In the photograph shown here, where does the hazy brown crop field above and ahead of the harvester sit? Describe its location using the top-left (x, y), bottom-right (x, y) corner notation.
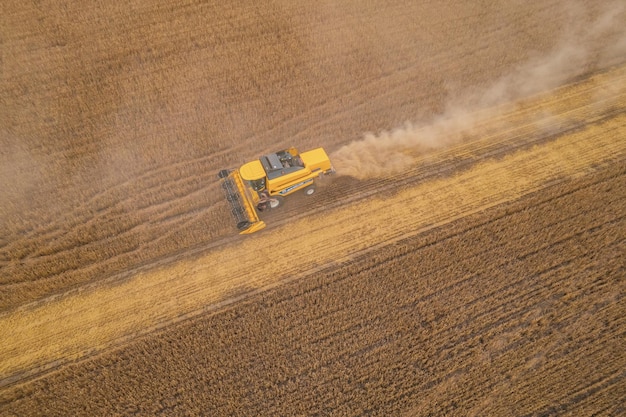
top-left (0, 0), bottom-right (620, 311)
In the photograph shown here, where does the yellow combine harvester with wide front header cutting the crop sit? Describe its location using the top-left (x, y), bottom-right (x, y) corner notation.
top-left (218, 148), bottom-right (335, 234)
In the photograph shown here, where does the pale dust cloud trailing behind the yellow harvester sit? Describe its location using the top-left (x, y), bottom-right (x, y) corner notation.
top-left (331, 1), bottom-right (626, 179)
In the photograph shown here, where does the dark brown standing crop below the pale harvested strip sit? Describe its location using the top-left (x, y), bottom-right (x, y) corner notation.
top-left (0, 158), bottom-right (626, 416)
